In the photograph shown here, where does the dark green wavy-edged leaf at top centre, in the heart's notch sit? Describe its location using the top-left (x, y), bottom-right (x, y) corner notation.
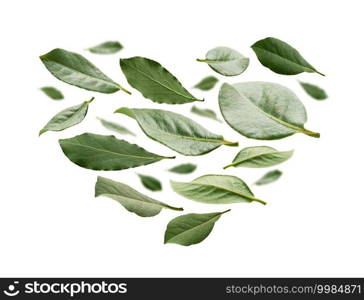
top-left (120, 56), bottom-right (203, 104)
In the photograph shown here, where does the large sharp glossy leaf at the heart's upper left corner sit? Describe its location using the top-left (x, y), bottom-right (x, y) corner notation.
top-left (40, 48), bottom-right (131, 94)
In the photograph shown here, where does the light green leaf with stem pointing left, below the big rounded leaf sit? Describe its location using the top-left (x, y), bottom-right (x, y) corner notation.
top-left (224, 146), bottom-right (293, 169)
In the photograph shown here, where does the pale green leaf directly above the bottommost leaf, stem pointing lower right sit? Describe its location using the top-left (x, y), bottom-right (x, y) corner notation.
top-left (171, 175), bottom-right (266, 204)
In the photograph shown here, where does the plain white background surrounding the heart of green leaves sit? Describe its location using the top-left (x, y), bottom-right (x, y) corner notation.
top-left (0, 0), bottom-right (364, 276)
